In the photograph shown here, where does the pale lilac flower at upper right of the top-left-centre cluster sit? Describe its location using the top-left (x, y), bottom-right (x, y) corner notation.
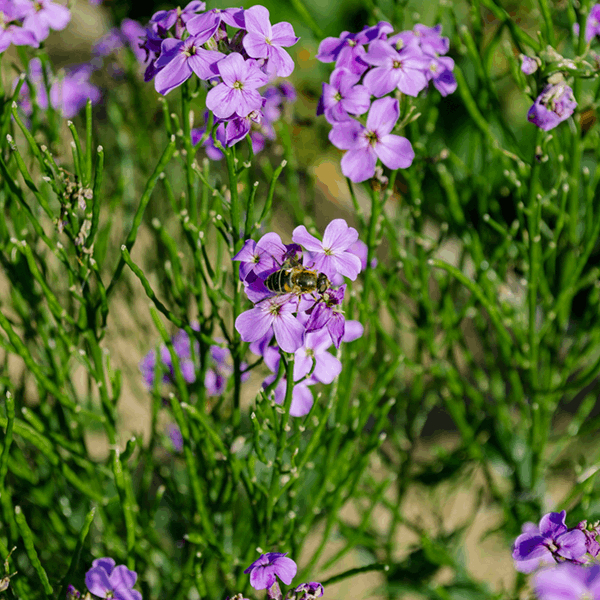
top-left (243, 5), bottom-right (300, 77)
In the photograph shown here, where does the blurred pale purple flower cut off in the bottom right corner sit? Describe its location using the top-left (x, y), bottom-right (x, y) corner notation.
top-left (534, 563), bottom-right (600, 600)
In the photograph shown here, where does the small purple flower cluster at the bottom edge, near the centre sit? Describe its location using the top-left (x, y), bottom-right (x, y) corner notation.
top-left (236, 552), bottom-right (324, 600)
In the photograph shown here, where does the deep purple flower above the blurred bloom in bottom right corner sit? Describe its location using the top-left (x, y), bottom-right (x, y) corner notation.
top-left (512, 510), bottom-right (587, 571)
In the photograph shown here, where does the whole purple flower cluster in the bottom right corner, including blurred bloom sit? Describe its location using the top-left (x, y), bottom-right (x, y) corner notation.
top-left (512, 510), bottom-right (600, 600)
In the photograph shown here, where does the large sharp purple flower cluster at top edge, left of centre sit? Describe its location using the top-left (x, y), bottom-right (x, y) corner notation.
top-left (142, 0), bottom-right (298, 146)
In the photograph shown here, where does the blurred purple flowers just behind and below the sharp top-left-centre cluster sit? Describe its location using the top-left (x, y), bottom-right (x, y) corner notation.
top-left (192, 81), bottom-right (296, 160)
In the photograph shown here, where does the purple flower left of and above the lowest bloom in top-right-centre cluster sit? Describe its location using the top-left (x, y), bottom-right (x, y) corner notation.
top-left (317, 68), bottom-right (371, 123)
